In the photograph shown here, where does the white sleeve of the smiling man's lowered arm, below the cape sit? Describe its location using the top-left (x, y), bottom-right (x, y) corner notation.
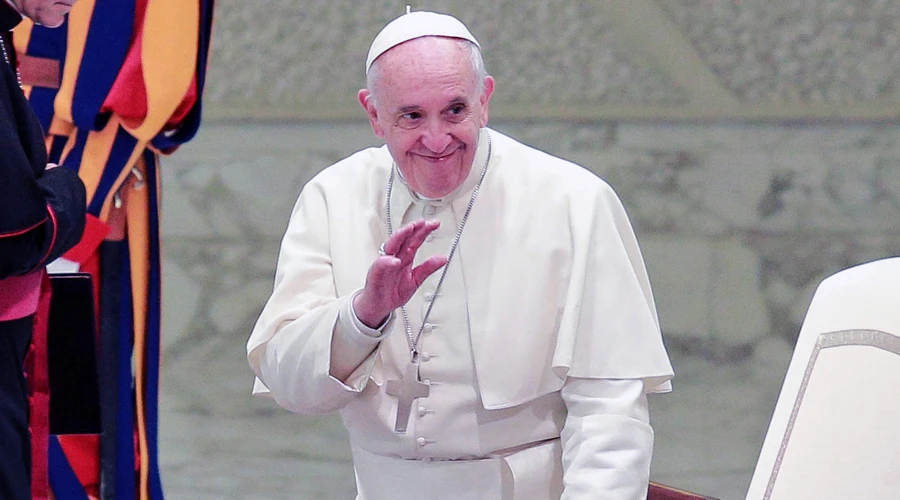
top-left (561, 378), bottom-right (653, 500)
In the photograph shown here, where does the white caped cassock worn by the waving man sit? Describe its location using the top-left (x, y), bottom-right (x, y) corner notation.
top-left (247, 129), bottom-right (673, 500)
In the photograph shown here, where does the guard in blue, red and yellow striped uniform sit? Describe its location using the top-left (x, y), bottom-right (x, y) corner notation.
top-left (13, 0), bottom-right (214, 500)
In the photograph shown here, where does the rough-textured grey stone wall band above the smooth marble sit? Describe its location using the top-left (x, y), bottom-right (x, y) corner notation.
top-left (206, 0), bottom-right (900, 119)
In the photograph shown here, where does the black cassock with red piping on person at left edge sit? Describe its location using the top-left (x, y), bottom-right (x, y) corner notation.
top-left (0, 4), bottom-right (85, 500)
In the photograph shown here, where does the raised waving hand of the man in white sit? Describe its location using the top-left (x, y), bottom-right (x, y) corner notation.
top-left (353, 219), bottom-right (447, 328)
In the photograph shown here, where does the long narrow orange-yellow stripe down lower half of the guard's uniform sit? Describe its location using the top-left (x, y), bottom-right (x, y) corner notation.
top-left (125, 158), bottom-right (150, 500)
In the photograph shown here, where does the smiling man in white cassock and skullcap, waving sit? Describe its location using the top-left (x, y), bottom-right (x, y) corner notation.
top-left (247, 8), bottom-right (673, 500)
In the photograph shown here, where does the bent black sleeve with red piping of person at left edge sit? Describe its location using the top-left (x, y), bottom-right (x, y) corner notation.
top-left (0, 167), bottom-right (86, 279)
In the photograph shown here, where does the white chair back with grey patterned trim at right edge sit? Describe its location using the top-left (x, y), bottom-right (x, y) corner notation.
top-left (747, 258), bottom-right (900, 500)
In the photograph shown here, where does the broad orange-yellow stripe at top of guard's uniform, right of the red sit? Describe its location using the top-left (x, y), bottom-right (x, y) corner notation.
top-left (126, 0), bottom-right (200, 141)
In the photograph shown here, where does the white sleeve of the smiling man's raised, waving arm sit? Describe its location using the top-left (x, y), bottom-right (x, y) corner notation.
top-left (247, 183), bottom-right (390, 414)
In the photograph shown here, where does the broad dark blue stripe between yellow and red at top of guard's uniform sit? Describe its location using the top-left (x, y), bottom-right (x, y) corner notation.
top-left (72, 0), bottom-right (135, 130)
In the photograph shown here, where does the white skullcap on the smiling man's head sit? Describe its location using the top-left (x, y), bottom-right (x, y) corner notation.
top-left (366, 11), bottom-right (481, 73)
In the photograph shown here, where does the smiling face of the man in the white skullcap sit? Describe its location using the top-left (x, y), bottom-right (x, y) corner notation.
top-left (359, 37), bottom-right (494, 198)
